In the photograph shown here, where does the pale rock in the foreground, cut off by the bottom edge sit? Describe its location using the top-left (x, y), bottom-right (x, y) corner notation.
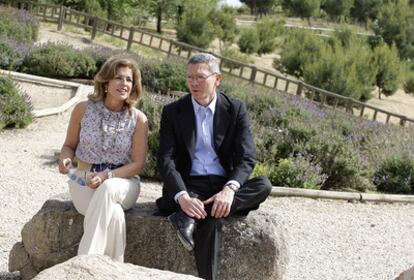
top-left (34, 255), bottom-right (201, 280)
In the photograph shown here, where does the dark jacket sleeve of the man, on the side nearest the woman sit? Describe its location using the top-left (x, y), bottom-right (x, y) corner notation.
top-left (157, 105), bottom-right (187, 198)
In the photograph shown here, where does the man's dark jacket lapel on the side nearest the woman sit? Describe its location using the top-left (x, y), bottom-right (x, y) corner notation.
top-left (178, 94), bottom-right (196, 159)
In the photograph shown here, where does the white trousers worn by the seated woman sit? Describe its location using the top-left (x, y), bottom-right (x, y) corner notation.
top-left (69, 171), bottom-right (140, 262)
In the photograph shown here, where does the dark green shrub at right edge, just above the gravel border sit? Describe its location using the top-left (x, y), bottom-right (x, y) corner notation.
top-left (373, 155), bottom-right (414, 194)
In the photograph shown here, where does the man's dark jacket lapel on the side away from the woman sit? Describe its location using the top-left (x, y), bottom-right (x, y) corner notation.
top-left (213, 92), bottom-right (231, 152)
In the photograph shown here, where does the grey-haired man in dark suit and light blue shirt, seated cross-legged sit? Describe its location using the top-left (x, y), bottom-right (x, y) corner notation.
top-left (157, 53), bottom-right (271, 279)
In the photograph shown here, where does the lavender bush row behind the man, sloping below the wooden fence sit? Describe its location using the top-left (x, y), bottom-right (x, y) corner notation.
top-left (138, 60), bottom-right (414, 193)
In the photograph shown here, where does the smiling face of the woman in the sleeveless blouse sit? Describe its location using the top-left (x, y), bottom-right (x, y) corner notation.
top-left (106, 66), bottom-right (133, 101)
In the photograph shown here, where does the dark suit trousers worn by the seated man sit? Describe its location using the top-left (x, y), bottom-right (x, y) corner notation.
top-left (157, 176), bottom-right (272, 279)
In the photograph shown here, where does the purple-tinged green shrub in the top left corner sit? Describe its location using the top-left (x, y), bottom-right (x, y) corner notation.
top-left (0, 6), bottom-right (39, 43)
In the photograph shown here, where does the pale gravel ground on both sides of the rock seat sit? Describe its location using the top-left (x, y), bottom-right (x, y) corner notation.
top-left (0, 83), bottom-right (414, 280)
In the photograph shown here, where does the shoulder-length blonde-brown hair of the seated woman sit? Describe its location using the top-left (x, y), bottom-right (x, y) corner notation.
top-left (88, 57), bottom-right (143, 114)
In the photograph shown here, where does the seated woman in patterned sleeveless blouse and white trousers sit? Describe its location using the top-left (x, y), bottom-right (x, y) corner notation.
top-left (59, 57), bottom-right (148, 262)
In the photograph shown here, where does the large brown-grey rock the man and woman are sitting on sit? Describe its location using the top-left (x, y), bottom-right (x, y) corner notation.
top-left (9, 194), bottom-right (288, 280)
